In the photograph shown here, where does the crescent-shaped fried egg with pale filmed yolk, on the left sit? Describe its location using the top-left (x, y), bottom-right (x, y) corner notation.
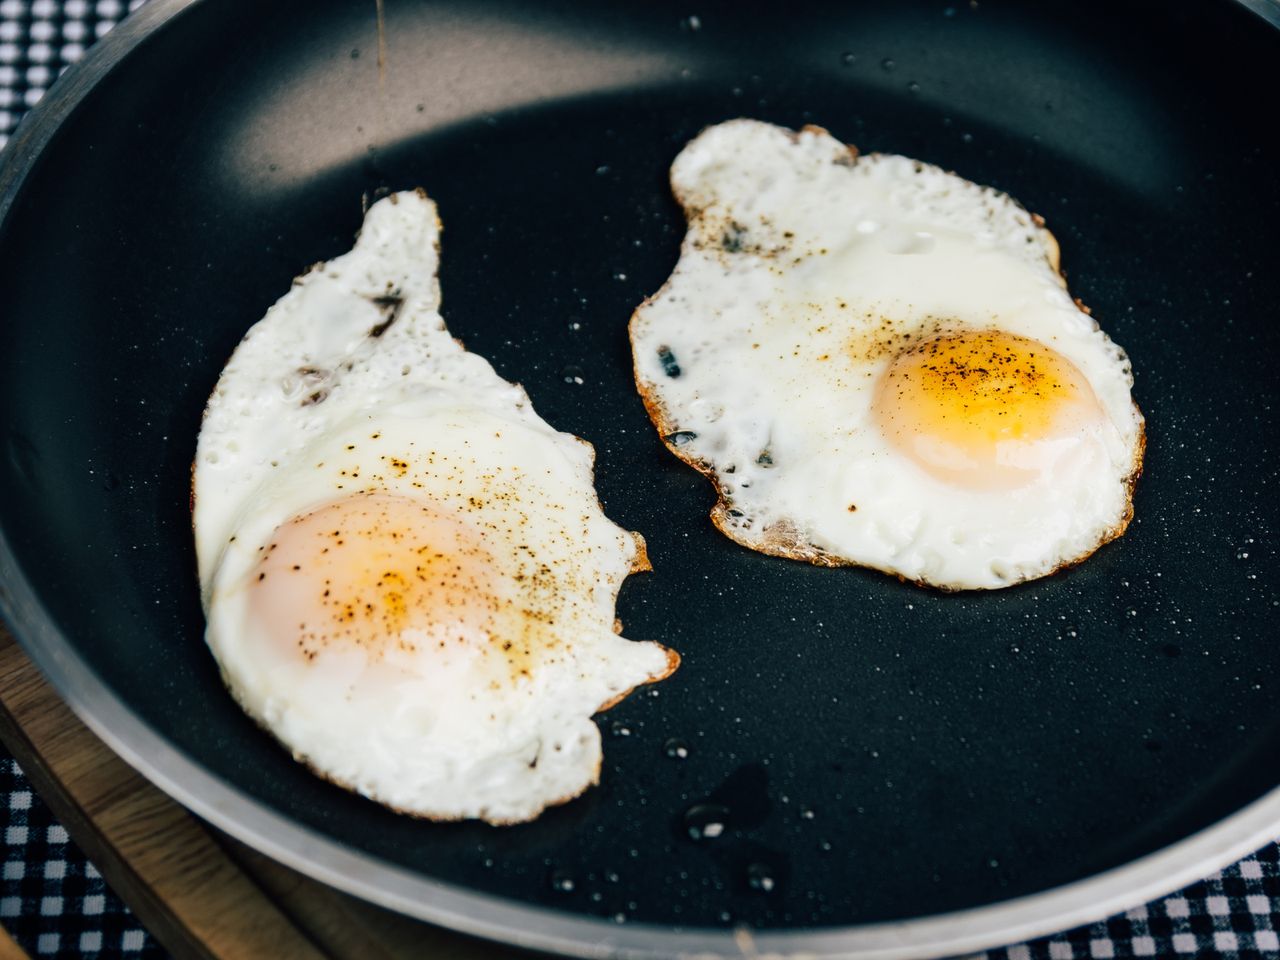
top-left (193, 192), bottom-right (678, 823)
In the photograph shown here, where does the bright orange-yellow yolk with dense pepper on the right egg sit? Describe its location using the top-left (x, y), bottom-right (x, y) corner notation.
top-left (873, 330), bottom-right (1106, 490)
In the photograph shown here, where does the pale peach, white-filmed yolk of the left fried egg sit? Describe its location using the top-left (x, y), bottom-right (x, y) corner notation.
top-left (248, 494), bottom-right (511, 662)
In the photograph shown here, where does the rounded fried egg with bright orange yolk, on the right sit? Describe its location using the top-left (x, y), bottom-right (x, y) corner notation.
top-left (631, 120), bottom-right (1144, 589)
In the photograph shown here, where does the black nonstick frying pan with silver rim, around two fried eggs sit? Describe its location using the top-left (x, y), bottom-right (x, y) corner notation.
top-left (0, 0), bottom-right (1280, 956)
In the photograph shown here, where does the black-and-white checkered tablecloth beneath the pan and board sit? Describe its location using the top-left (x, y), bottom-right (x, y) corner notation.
top-left (0, 0), bottom-right (1280, 960)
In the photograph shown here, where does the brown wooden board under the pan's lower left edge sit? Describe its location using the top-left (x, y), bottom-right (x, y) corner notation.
top-left (0, 626), bottom-right (534, 960)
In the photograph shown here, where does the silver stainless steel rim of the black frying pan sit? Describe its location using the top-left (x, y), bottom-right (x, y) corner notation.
top-left (0, 0), bottom-right (1280, 960)
